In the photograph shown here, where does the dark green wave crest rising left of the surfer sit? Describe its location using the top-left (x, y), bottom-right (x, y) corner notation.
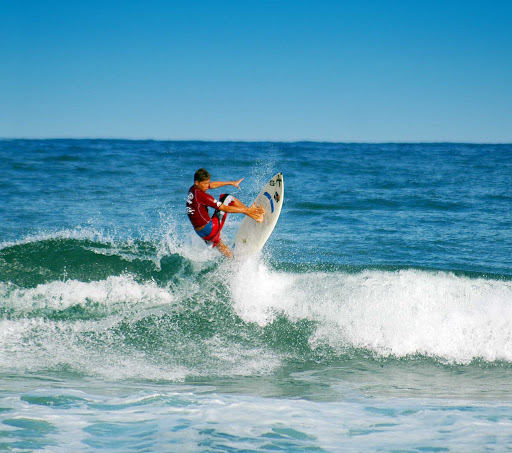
top-left (0, 232), bottom-right (206, 288)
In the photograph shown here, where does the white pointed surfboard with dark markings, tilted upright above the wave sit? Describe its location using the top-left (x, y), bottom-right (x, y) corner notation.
top-left (235, 173), bottom-right (284, 256)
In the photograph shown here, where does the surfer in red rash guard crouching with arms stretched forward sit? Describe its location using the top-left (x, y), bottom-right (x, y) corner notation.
top-left (187, 168), bottom-right (265, 258)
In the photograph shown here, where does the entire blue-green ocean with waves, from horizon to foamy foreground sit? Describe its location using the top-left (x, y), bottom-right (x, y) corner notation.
top-left (0, 140), bottom-right (512, 453)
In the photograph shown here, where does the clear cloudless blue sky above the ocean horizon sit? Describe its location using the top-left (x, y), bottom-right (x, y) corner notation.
top-left (0, 0), bottom-right (512, 143)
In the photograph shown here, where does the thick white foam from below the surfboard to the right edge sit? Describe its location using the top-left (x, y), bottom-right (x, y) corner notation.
top-left (231, 261), bottom-right (512, 363)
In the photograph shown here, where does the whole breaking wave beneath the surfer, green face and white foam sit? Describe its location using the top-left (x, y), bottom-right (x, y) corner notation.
top-left (0, 236), bottom-right (512, 381)
